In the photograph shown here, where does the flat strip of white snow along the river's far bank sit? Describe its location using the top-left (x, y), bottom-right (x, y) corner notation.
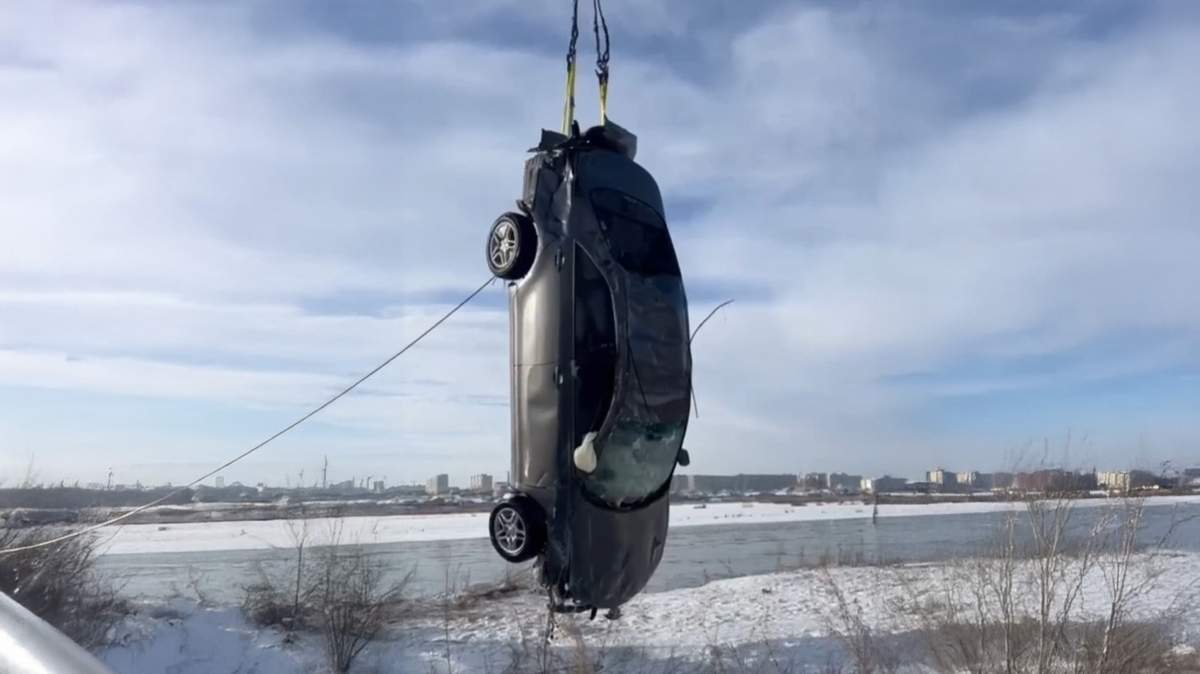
top-left (101, 495), bottom-right (1200, 554)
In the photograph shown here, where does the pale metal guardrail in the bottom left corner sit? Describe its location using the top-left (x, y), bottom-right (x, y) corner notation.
top-left (0, 592), bottom-right (113, 674)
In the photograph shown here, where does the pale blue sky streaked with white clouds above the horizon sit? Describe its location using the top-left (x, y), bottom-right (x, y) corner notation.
top-left (0, 0), bottom-right (1200, 485)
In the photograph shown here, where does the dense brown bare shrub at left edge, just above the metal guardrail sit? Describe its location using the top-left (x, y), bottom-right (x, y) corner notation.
top-left (0, 528), bottom-right (128, 648)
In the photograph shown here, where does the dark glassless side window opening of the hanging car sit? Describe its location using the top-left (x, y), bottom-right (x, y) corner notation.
top-left (575, 246), bottom-right (617, 446)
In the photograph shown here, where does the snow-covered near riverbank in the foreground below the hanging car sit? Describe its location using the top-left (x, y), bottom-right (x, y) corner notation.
top-left (101, 553), bottom-right (1200, 674)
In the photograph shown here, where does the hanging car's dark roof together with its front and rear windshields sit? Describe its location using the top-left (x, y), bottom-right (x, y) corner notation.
top-left (586, 191), bottom-right (690, 506)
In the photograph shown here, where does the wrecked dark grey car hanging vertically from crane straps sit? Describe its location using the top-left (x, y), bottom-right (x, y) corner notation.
top-left (487, 121), bottom-right (691, 612)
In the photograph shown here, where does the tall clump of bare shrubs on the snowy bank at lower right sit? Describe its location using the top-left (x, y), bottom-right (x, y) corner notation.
top-left (898, 486), bottom-right (1188, 674)
